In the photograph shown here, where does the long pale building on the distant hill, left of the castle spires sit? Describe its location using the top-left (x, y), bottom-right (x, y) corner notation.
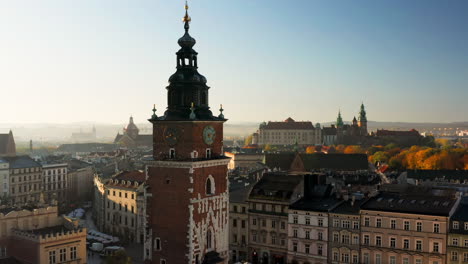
top-left (254, 117), bottom-right (322, 146)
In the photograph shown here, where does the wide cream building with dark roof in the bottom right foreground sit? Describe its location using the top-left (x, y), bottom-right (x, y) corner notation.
top-left (361, 192), bottom-right (460, 264)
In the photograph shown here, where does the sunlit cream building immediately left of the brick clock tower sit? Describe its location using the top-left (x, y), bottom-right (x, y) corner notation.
top-left (94, 171), bottom-right (146, 243)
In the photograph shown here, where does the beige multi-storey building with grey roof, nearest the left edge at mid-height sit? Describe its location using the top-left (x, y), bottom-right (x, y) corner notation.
top-left (3, 156), bottom-right (42, 204)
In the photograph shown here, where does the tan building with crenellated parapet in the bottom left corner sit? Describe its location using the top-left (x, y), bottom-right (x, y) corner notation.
top-left (0, 207), bottom-right (87, 264)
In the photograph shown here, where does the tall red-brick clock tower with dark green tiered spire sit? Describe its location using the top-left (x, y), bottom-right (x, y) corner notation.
top-left (145, 4), bottom-right (229, 264)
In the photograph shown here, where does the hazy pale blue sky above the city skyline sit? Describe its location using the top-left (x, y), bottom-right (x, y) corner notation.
top-left (0, 0), bottom-right (468, 123)
